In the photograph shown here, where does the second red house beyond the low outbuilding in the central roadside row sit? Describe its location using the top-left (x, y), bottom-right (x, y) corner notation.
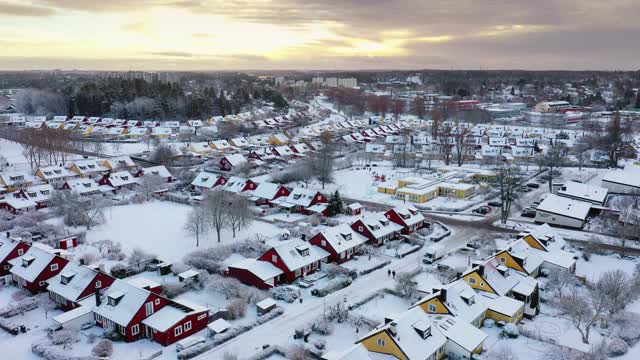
top-left (309, 224), bottom-right (368, 263)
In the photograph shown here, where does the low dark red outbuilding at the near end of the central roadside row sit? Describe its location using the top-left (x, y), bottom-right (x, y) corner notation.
top-left (227, 259), bottom-right (284, 290)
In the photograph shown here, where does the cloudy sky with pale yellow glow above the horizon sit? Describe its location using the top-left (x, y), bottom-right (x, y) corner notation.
top-left (0, 0), bottom-right (640, 71)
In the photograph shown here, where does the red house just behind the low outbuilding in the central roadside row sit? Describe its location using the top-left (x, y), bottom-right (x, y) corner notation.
top-left (258, 239), bottom-right (329, 283)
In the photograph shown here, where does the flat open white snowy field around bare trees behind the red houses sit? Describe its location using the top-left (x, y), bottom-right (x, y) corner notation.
top-left (77, 201), bottom-right (281, 261)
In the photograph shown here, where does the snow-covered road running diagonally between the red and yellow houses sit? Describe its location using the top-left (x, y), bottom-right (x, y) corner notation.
top-left (197, 227), bottom-right (476, 359)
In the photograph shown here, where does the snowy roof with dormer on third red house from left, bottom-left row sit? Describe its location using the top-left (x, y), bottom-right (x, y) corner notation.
top-left (47, 261), bottom-right (98, 301)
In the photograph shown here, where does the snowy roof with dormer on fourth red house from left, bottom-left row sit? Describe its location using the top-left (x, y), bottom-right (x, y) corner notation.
top-left (94, 279), bottom-right (151, 326)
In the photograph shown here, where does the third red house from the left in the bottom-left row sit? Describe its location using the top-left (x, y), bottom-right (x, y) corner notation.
top-left (47, 262), bottom-right (114, 310)
